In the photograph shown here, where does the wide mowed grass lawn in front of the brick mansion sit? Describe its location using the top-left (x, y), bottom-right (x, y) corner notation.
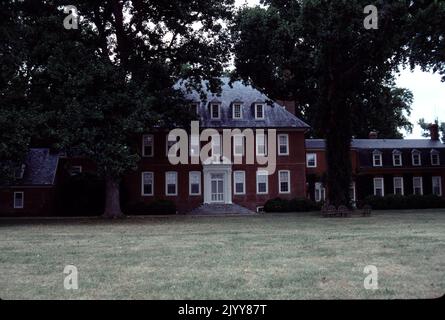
top-left (0, 210), bottom-right (445, 299)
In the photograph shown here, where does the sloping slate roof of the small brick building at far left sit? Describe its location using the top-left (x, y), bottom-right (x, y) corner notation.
top-left (19, 148), bottom-right (59, 185)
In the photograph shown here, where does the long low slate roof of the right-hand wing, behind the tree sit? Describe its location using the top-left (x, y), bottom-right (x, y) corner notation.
top-left (306, 139), bottom-right (445, 149)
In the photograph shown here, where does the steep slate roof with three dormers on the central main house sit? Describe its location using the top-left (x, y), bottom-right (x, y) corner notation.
top-left (176, 77), bottom-right (309, 129)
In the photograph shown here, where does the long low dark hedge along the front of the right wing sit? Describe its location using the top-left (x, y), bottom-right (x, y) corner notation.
top-left (362, 194), bottom-right (445, 210)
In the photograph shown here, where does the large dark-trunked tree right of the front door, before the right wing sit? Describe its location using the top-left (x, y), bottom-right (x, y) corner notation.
top-left (231, 0), bottom-right (445, 205)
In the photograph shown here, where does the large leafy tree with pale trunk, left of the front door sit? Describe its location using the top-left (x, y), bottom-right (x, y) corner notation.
top-left (5, 0), bottom-right (233, 217)
